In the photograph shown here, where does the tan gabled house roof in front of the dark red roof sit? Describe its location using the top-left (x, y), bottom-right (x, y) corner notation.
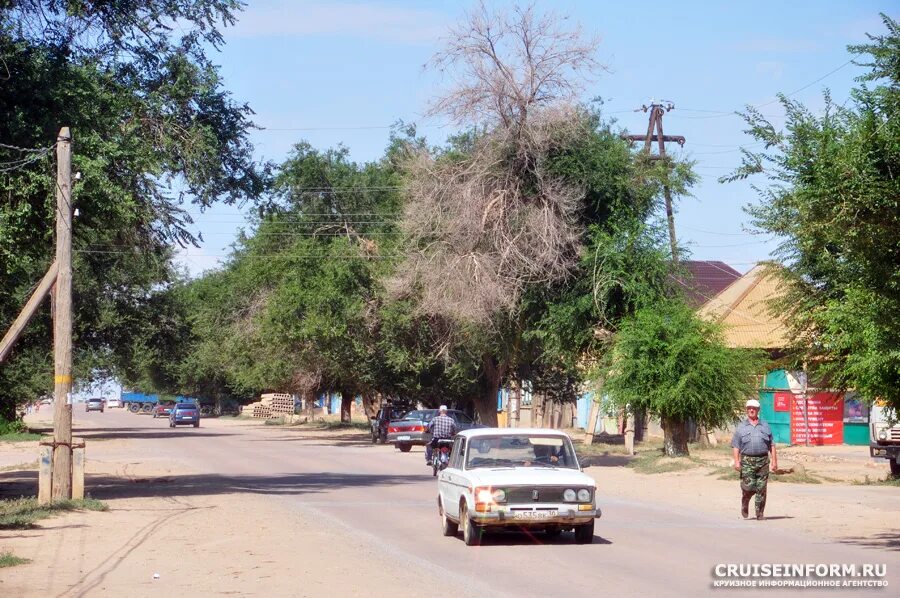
top-left (697, 264), bottom-right (790, 349)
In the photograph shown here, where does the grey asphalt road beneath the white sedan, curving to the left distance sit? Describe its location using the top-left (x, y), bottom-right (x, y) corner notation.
top-left (76, 410), bottom-right (900, 597)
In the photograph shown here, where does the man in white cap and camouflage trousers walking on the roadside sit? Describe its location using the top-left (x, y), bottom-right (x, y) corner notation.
top-left (731, 399), bottom-right (778, 519)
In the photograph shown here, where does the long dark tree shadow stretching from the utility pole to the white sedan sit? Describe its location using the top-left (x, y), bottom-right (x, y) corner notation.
top-left (0, 471), bottom-right (423, 500)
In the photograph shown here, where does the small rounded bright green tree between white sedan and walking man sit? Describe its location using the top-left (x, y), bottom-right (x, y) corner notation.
top-left (597, 300), bottom-right (762, 457)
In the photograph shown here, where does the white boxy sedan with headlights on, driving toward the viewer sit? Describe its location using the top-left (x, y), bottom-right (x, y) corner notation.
top-left (438, 428), bottom-right (600, 546)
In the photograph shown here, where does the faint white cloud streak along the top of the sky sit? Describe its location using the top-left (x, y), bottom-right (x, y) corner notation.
top-left (226, 3), bottom-right (446, 43)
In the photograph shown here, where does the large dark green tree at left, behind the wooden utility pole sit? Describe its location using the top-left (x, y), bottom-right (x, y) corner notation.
top-left (0, 0), bottom-right (266, 418)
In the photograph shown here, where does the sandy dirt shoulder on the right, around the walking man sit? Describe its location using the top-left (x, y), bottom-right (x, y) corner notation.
top-left (584, 434), bottom-right (900, 550)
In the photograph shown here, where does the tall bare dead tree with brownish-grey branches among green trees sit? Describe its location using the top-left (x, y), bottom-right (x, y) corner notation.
top-left (392, 4), bottom-right (601, 322)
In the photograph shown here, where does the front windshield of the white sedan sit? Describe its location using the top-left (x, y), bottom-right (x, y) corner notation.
top-left (466, 434), bottom-right (578, 469)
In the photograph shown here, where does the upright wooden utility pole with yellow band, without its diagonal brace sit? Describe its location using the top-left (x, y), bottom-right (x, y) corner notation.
top-left (51, 127), bottom-right (72, 500)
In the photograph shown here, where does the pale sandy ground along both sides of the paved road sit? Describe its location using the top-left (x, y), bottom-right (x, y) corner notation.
top-left (0, 416), bottom-right (900, 597)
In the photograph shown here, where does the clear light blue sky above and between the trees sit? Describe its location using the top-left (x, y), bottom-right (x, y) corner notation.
top-left (172, 0), bottom-right (900, 274)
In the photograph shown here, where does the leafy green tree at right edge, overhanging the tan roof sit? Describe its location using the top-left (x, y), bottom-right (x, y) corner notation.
top-left (725, 15), bottom-right (900, 408)
